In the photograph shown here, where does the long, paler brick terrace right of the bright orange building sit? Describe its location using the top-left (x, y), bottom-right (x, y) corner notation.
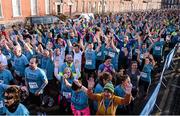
top-left (52, 0), bottom-right (161, 14)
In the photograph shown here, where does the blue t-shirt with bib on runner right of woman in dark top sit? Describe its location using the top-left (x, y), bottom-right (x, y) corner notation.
top-left (140, 64), bottom-right (153, 82)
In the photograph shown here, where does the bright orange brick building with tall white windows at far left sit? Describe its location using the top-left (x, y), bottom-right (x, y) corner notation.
top-left (0, 0), bottom-right (51, 25)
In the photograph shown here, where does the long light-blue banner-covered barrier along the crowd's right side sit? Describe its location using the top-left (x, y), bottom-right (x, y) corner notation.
top-left (140, 44), bottom-right (180, 115)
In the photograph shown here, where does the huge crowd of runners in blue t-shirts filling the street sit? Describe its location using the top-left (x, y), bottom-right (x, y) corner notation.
top-left (0, 9), bottom-right (180, 115)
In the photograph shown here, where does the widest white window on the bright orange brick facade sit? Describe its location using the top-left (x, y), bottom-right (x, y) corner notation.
top-left (12, 0), bottom-right (21, 17)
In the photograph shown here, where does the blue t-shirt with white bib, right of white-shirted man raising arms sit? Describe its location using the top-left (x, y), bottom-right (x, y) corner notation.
top-left (85, 50), bottom-right (96, 69)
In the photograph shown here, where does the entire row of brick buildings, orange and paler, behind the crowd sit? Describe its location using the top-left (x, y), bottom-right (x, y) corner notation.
top-left (0, 0), bottom-right (161, 24)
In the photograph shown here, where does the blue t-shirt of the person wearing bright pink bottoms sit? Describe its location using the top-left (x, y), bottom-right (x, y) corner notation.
top-left (71, 90), bottom-right (89, 110)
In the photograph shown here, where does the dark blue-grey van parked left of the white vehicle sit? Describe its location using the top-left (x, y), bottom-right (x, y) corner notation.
top-left (26, 16), bottom-right (61, 25)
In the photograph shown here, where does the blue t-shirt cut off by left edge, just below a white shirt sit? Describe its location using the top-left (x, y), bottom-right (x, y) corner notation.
top-left (0, 69), bottom-right (13, 85)
